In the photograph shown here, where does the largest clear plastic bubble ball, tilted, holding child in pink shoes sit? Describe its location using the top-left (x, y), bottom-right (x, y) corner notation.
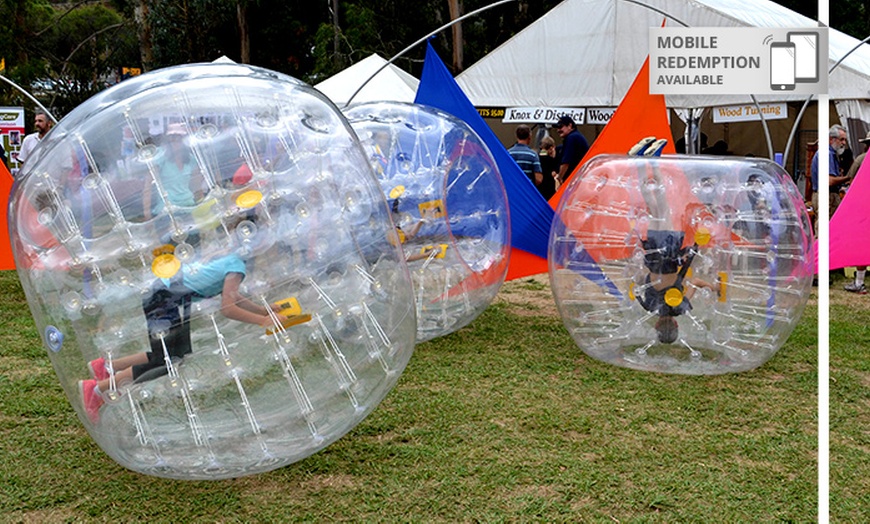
top-left (10, 64), bottom-right (416, 479)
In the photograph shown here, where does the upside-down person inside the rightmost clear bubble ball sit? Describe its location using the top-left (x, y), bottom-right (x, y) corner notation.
top-left (629, 138), bottom-right (719, 344)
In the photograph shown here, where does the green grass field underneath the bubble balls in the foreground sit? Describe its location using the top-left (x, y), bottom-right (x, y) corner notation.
top-left (0, 272), bottom-right (848, 523)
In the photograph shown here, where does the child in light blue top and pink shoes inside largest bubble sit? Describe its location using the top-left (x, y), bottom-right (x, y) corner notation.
top-left (78, 208), bottom-right (311, 423)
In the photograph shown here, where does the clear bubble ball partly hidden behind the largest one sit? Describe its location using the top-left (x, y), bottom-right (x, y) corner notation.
top-left (344, 102), bottom-right (510, 342)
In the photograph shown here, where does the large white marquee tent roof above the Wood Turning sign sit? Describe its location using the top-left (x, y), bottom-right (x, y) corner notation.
top-left (456, 0), bottom-right (870, 111)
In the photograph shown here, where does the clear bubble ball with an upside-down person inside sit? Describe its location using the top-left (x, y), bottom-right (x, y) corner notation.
top-left (549, 156), bottom-right (813, 375)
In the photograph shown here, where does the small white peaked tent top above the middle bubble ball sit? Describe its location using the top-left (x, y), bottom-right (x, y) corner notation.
top-left (314, 54), bottom-right (420, 107)
